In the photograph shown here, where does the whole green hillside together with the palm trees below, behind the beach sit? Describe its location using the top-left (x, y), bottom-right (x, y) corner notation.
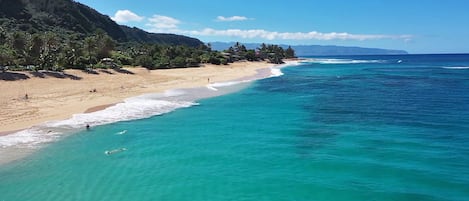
top-left (0, 0), bottom-right (295, 71)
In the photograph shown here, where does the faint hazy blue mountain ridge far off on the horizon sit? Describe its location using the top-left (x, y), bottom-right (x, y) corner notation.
top-left (210, 42), bottom-right (408, 56)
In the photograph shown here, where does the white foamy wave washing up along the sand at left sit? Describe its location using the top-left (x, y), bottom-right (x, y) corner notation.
top-left (0, 95), bottom-right (197, 148)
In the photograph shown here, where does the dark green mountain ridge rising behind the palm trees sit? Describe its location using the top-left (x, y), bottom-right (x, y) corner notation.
top-left (0, 0), bottom-right (203, 47)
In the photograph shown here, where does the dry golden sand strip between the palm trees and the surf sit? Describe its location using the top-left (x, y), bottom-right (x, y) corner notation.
top-left (0, 62), bottom-right (273, 136)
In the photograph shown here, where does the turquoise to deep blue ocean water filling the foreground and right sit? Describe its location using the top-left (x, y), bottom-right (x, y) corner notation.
top-left (0, 55), bottom-right (469, 201)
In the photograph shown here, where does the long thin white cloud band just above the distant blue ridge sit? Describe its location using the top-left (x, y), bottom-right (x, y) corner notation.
top-left (182, 28), bottom-right (412, 40)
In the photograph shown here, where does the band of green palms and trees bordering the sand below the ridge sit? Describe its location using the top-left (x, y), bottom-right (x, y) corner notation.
top-left (0, 27), bottom-right (295, 71)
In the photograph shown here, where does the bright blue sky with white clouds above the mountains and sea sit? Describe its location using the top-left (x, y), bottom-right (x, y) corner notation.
top-left (77, 0), bottom-right (469, 53)
